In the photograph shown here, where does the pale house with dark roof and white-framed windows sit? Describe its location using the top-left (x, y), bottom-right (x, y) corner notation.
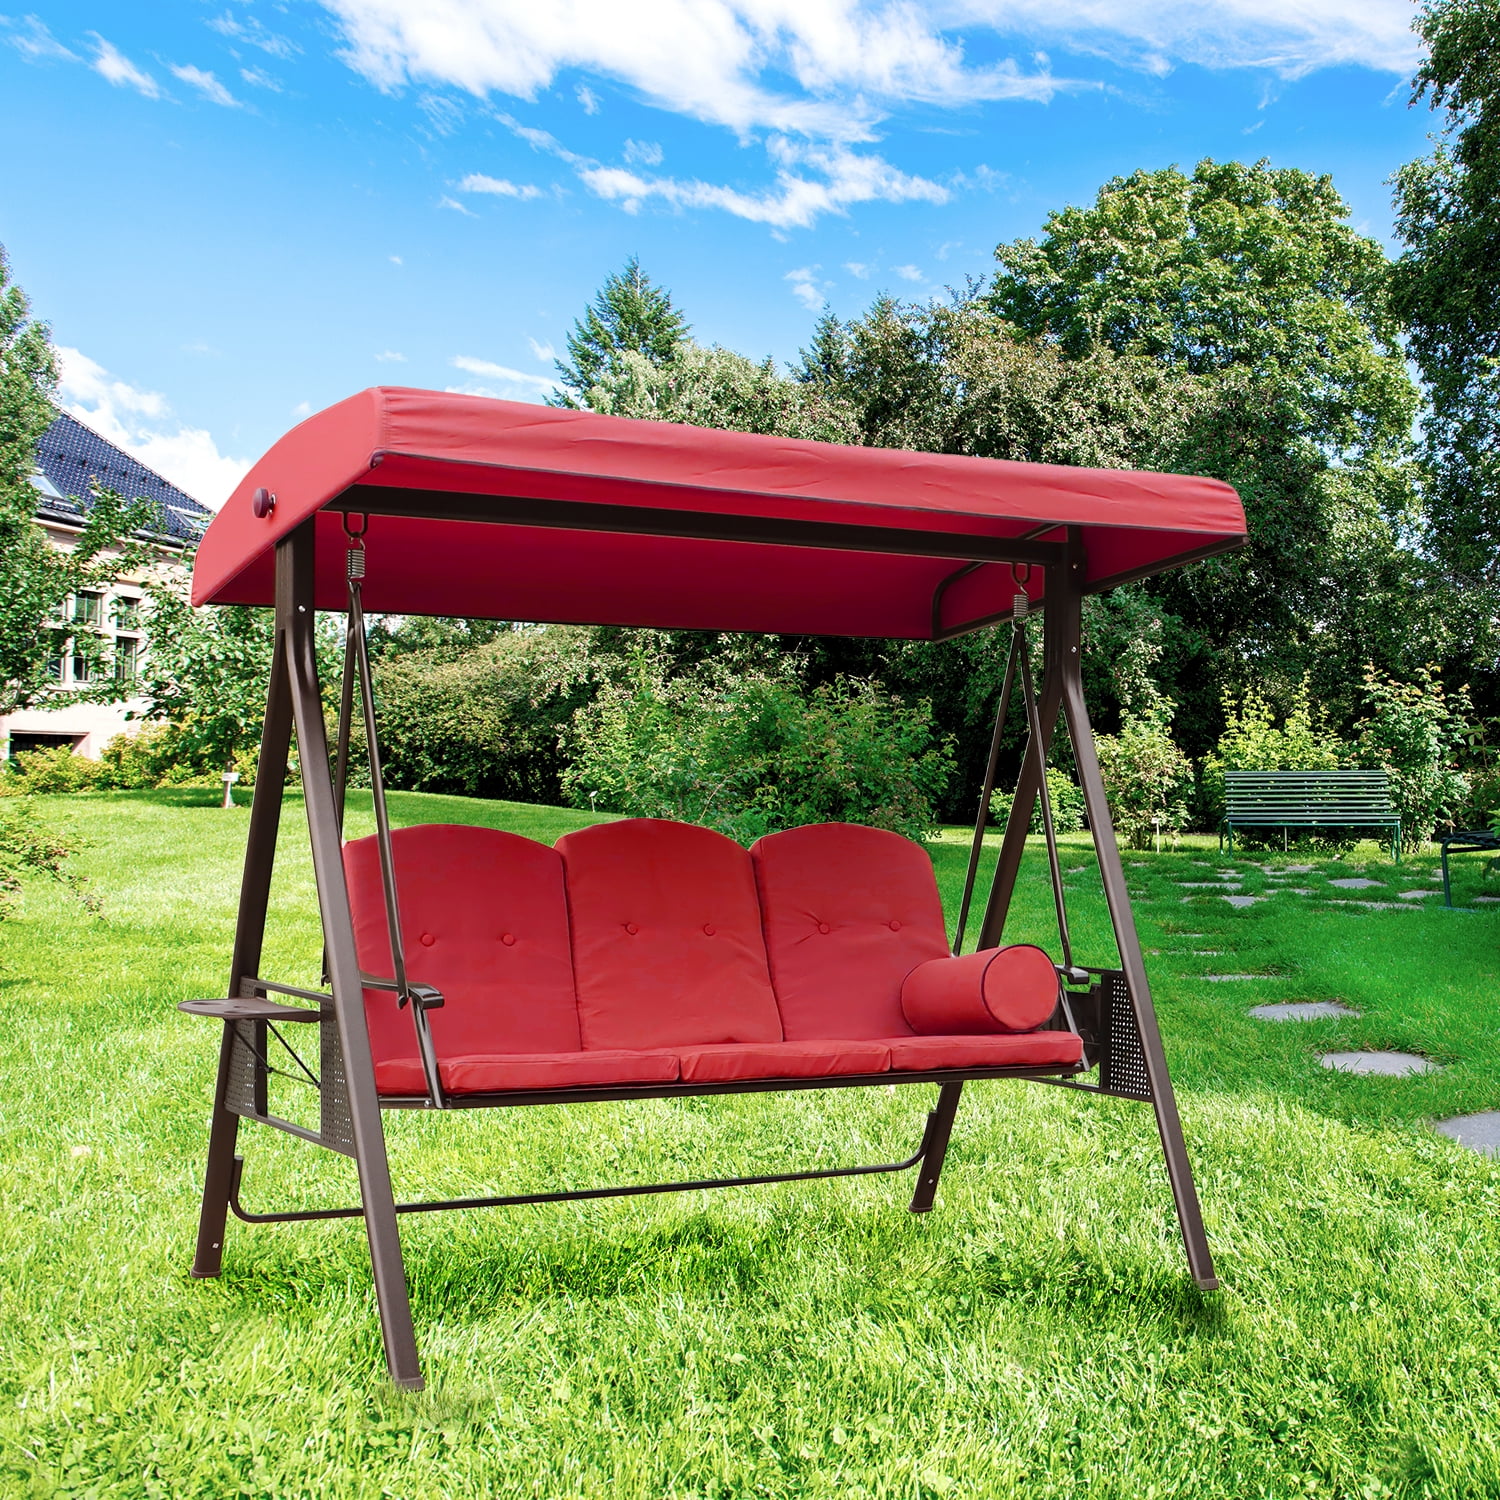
top-left (0, 411), bottom-right (213, 756)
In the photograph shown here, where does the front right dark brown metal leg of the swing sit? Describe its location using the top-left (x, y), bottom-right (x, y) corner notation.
top-left (1047, 530), bottom-right (1218, 1292)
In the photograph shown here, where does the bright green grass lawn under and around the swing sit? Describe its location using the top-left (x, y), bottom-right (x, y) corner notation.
top-left (0, 792), bottom-right (1500, 1500)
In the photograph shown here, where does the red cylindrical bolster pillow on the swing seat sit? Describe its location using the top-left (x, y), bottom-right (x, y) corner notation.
top-left (902, 942), bottom-right (1058, 1037)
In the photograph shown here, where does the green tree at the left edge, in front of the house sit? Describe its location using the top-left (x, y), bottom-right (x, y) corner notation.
top-left (0, 248), bottom-right (158, 714)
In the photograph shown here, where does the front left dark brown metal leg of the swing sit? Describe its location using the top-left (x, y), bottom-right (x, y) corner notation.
top-left (276, 521), bottom-right (423, 1391)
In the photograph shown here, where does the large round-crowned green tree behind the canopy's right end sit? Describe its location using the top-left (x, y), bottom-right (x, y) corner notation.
top-left (990, 161), bottom-right (1437, 750)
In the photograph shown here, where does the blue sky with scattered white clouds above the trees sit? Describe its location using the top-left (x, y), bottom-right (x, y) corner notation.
top-left (0, 0), bottom-right (1433, 506)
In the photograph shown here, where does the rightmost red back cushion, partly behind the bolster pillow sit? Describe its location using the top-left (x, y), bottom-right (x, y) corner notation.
top-left (750, 824), bottom-right (948, 1041)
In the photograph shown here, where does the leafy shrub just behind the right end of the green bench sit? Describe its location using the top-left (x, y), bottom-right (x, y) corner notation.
top-left (1356, 666), bottom-right (1473, 843)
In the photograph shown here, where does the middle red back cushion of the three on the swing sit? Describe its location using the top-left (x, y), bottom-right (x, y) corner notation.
top-left (558, 818), bottom-right (782, 1047)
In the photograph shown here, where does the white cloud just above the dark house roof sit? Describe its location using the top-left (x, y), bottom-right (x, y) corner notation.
top-left (57, 347), bottom-right (251, 510)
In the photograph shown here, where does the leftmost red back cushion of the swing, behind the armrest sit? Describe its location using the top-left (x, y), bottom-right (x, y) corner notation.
top-left (344, 824), bottom-right (579, 1065)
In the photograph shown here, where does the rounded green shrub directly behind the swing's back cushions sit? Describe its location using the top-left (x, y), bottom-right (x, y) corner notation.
top-left (563, 653), bottom-right (953, 843)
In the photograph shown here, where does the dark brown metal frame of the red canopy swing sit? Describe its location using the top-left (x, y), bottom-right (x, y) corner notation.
top-left (185, 516), bottom-right (1218, 1389)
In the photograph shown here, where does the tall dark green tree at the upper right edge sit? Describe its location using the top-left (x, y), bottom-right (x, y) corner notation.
top-left (1394, 0), bottom-right (1500, 594)
